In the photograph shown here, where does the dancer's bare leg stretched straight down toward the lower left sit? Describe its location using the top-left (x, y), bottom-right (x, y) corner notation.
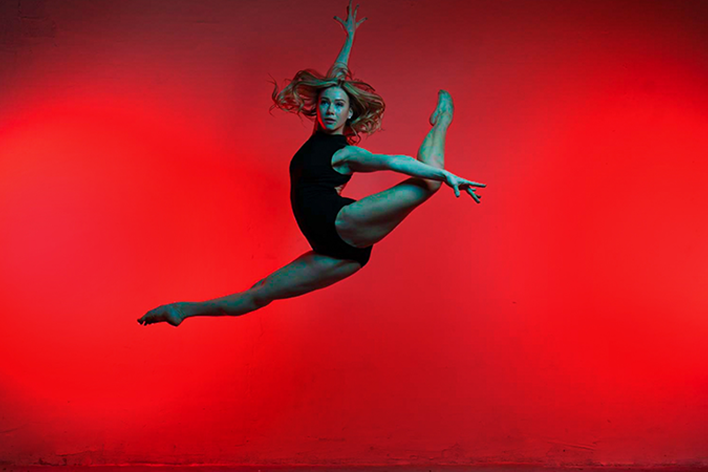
top-left (138, 251), bottom-right (361, 326)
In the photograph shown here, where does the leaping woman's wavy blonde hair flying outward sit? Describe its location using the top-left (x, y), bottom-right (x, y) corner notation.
top-left (268, 62), bottom-right (386, 145)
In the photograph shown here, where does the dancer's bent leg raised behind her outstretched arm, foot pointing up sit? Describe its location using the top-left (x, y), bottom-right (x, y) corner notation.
top-left (335, 90), bottom-right (453, 247)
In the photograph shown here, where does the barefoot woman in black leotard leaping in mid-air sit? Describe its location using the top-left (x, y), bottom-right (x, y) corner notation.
top-left (138, 0), bottom-right (486, 326)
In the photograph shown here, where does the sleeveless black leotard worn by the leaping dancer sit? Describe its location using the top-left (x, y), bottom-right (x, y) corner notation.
top-left (290, 130), bottom-right (373, 267)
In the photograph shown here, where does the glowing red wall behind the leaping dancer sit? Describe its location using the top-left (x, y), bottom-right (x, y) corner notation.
top-left (0, 0), bottom-right (708, 465)
